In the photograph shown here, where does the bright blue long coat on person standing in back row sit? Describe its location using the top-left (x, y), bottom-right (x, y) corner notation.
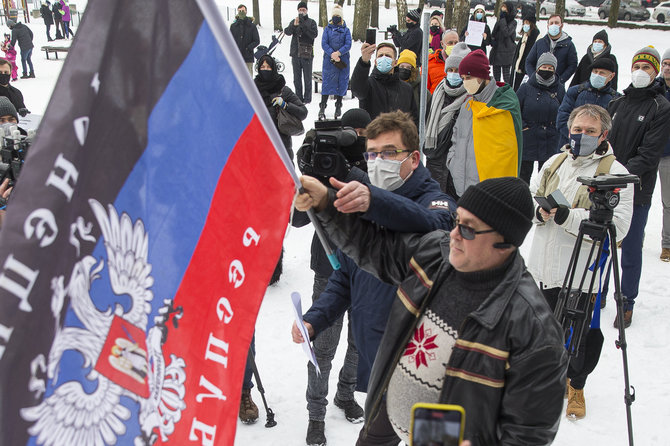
top-left (321, 21), bottom-right (351, 96)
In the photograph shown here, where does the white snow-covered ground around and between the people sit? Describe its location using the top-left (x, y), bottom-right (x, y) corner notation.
top-left (11, 0), bottom-right (670, 446)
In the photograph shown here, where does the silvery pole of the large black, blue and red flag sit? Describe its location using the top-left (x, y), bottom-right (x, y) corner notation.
top-left (196, 0), bottom-right (340, 269)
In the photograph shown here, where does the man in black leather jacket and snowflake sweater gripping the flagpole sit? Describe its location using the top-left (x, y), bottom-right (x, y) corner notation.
top-left (295, 177), bottom-right (567, 446)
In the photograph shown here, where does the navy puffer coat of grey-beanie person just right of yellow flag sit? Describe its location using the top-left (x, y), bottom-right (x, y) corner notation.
top-left (516, 72), bottom-right (565, 166)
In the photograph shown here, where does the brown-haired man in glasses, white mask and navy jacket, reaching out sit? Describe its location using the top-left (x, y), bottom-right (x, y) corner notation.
top-left (292, 112), bottom-right (455, 444)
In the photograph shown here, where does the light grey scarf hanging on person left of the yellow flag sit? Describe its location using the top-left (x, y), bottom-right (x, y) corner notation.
top-left (424, 77), bottom-right (467, 152)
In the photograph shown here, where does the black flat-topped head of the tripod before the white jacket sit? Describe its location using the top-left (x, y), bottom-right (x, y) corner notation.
top-left (577, 174), bottom-right (640, 223)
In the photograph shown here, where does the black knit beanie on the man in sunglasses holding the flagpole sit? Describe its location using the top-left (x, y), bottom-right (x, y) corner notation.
top-left (458, 177), bottom-right (533, 246)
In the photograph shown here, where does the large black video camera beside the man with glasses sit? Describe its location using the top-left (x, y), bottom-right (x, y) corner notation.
top-left (297, 120), bottom-right (365, 185)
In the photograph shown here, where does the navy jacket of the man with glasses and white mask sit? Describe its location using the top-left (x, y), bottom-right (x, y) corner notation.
top-left (303, 164), bottom-right (456, 392)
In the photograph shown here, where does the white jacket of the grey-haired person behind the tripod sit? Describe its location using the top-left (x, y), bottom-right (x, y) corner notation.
top-left (528, 146), bottom-right (633, 291)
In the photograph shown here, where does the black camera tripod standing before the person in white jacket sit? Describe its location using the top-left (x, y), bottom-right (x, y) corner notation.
top-left (554, 190), bottom-right (635, 446)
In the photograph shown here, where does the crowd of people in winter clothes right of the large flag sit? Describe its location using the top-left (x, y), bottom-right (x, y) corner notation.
top-left (224, 2), bottom-right (670, 445)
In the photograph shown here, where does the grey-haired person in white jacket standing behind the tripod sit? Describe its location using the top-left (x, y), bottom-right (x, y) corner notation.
top-left (528, 104), bottom-right (633, 419)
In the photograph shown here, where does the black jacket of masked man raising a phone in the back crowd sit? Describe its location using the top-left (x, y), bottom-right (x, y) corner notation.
top-left (351, 59), bottom-right (419, 127)
